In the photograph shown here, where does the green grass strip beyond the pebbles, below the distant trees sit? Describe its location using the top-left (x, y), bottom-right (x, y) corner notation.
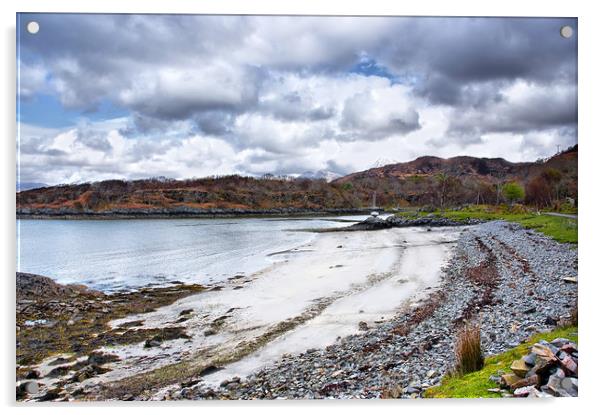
top-left (399, 205), bottom-right (577, 244)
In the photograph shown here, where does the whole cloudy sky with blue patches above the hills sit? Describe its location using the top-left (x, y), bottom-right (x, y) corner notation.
top-left (17, 14), bottom-right (577, 184)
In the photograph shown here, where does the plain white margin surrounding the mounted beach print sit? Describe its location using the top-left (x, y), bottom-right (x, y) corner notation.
top-left (0, 0), bottom-right (602, 415)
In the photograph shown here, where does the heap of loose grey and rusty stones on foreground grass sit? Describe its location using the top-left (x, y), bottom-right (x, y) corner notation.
top-left (494, 338), bottom-right (579, 397)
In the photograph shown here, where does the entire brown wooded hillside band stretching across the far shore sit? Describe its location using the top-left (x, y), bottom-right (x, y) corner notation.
top-left (17, 146), bottom-right (577, 216)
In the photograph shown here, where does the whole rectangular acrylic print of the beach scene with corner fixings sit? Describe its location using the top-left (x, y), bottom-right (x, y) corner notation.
top-left (16, 13), bottom-right (578, 401)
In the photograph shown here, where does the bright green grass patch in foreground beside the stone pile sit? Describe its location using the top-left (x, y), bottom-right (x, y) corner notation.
top-left (424, 326), bottom-right (578, 398)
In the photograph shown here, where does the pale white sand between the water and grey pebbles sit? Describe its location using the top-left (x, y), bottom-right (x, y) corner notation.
top-left (18, 228), bottom-right (461, 400)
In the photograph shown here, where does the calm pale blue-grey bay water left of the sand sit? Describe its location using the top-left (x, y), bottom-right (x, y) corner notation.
top-left (17, 216), bottom-right (364, 291)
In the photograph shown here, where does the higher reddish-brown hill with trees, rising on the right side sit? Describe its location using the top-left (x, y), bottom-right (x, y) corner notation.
top-left (332, 145), bottom-right (578, 210)
